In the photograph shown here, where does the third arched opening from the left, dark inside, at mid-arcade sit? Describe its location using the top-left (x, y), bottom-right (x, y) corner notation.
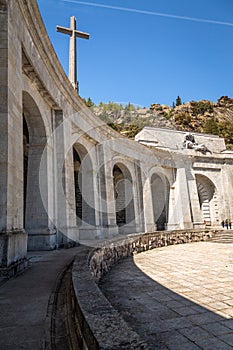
top-left (113, 163), bottom-right (135, 233)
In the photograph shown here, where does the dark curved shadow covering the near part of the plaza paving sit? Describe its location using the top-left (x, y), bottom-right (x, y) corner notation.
top-left (99, 254), bottom-right (233, 350)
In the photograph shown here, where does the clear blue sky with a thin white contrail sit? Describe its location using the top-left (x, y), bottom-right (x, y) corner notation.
top-left (38, 0), bottom-right (233, 106)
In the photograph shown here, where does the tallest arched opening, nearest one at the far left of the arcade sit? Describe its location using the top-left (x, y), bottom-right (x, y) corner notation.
top-left (22, 92), bottom-right (51, 250)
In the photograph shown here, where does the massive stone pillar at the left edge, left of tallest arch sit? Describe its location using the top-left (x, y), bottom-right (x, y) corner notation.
top-left (0, 1), bottom-right (27, 274)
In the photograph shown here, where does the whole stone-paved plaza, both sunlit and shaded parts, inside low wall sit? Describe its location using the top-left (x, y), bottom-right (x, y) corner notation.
top-left (101, 242), bottom-right (233, 350)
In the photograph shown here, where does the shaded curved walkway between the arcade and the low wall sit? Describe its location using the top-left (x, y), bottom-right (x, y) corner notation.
top-left (0, 247), bottom-right (79, 350)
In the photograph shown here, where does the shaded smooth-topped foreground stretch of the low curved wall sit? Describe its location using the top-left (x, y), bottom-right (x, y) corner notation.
top-left (72, 246), bottom-right (148, 350)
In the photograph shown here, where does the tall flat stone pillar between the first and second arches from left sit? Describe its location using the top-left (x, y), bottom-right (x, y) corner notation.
top-left (52, 110), bottom-right (76, 246)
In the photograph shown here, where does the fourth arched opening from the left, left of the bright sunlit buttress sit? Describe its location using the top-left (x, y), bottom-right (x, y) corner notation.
top-left (151, 174), bottom-right (170, 230)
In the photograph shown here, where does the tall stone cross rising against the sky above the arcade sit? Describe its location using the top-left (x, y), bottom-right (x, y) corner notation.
top-left (57, 16), bottom-right (90, 92)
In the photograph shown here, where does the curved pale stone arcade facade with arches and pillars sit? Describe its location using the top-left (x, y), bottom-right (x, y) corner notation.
top-left (0, 0), bottom-right (233, 267)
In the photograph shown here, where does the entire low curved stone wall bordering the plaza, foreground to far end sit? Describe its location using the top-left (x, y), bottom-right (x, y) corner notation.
top-left (72, 229), bottom-right (216, 350)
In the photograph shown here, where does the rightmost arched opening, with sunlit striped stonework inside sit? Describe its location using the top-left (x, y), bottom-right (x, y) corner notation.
top-left (196, 174), bottom-right (218, 225)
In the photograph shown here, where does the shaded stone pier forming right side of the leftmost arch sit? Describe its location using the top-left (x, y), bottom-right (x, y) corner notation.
top-left (25, 143), bottom-right (56, 250)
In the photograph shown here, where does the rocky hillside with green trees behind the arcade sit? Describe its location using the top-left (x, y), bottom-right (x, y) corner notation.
top-left (85, 96), bottom-right (233, 149)
